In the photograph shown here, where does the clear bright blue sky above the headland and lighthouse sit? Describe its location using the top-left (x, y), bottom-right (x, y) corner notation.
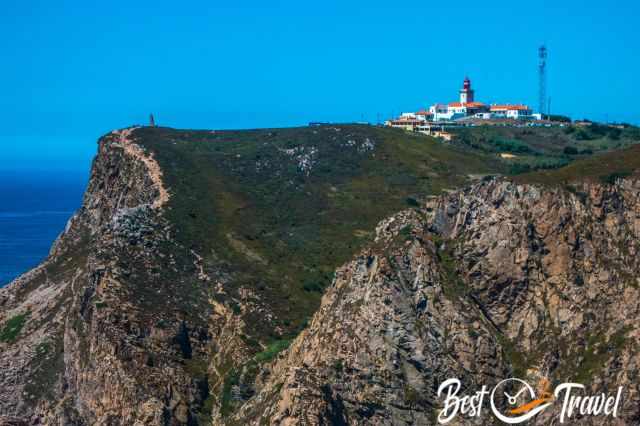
top-left (0, 0), bottom-right (640, 171)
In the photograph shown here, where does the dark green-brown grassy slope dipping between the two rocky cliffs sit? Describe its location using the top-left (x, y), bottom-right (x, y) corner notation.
top-left (135, 126), bottom-right (505, 339)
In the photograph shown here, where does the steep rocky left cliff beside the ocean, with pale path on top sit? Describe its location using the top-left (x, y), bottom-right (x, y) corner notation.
top-left (0, 129), bottom-right (211, 425)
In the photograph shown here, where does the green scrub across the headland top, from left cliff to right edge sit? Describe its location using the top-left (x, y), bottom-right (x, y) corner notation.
top-left (131, 125), bottom-right (640, 390)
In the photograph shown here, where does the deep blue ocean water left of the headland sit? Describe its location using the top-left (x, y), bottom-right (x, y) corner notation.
top-left (0, 171), bottom-right (87, 287)
